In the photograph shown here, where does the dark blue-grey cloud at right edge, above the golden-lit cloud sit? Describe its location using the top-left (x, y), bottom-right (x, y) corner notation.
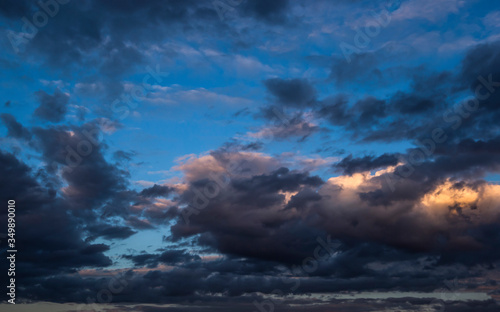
top-left (316, 42), bottom-right (500, 142)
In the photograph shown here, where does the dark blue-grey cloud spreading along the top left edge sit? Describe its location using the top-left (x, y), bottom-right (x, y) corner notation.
top-left (3, 0), bottom-right (229, 78)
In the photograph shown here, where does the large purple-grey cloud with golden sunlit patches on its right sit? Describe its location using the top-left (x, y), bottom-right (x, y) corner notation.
top-left (159, 147), bottom-right (500, 289)
